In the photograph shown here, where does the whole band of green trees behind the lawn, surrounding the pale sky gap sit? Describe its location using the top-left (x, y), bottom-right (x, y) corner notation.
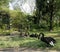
top-left (0, 0), bottom-right (60, 34)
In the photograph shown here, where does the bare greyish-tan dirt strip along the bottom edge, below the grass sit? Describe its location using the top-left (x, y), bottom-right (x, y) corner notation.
top-left (0, 47), bottom-right (60, 52)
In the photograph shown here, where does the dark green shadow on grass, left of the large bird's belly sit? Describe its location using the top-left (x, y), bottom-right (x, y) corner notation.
top-left (20, 40), bottom-right (50, 49)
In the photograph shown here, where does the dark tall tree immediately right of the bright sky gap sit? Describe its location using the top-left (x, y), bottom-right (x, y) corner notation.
top-left (35, 0), bottom-right (45, 24)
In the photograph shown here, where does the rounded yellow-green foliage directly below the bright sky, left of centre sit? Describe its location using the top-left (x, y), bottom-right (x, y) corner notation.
top-left (10, 10), bottom-right (27, 29)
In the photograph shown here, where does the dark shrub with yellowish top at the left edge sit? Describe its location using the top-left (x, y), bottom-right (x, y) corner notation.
top-left (0, 8), bottom-right (10, 29)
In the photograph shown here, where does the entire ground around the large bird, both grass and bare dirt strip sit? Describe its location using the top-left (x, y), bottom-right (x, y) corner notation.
top-left (0, 27), bottom-right (60, 52)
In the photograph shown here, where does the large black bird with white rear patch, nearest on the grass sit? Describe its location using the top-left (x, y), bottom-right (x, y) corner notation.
top-left (39, 33), bottom-right (56, 46)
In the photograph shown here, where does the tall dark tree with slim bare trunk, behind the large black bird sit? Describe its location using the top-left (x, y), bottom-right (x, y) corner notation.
top-left (46, 0), bottom-right (55, 31)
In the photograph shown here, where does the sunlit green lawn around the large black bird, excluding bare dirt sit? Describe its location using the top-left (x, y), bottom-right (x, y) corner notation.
top-left (0, 32), bottom-right (60, 50)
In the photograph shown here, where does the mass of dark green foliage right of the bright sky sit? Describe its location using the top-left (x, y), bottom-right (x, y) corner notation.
top-left (34, 0), bottom-right (60, 30)
